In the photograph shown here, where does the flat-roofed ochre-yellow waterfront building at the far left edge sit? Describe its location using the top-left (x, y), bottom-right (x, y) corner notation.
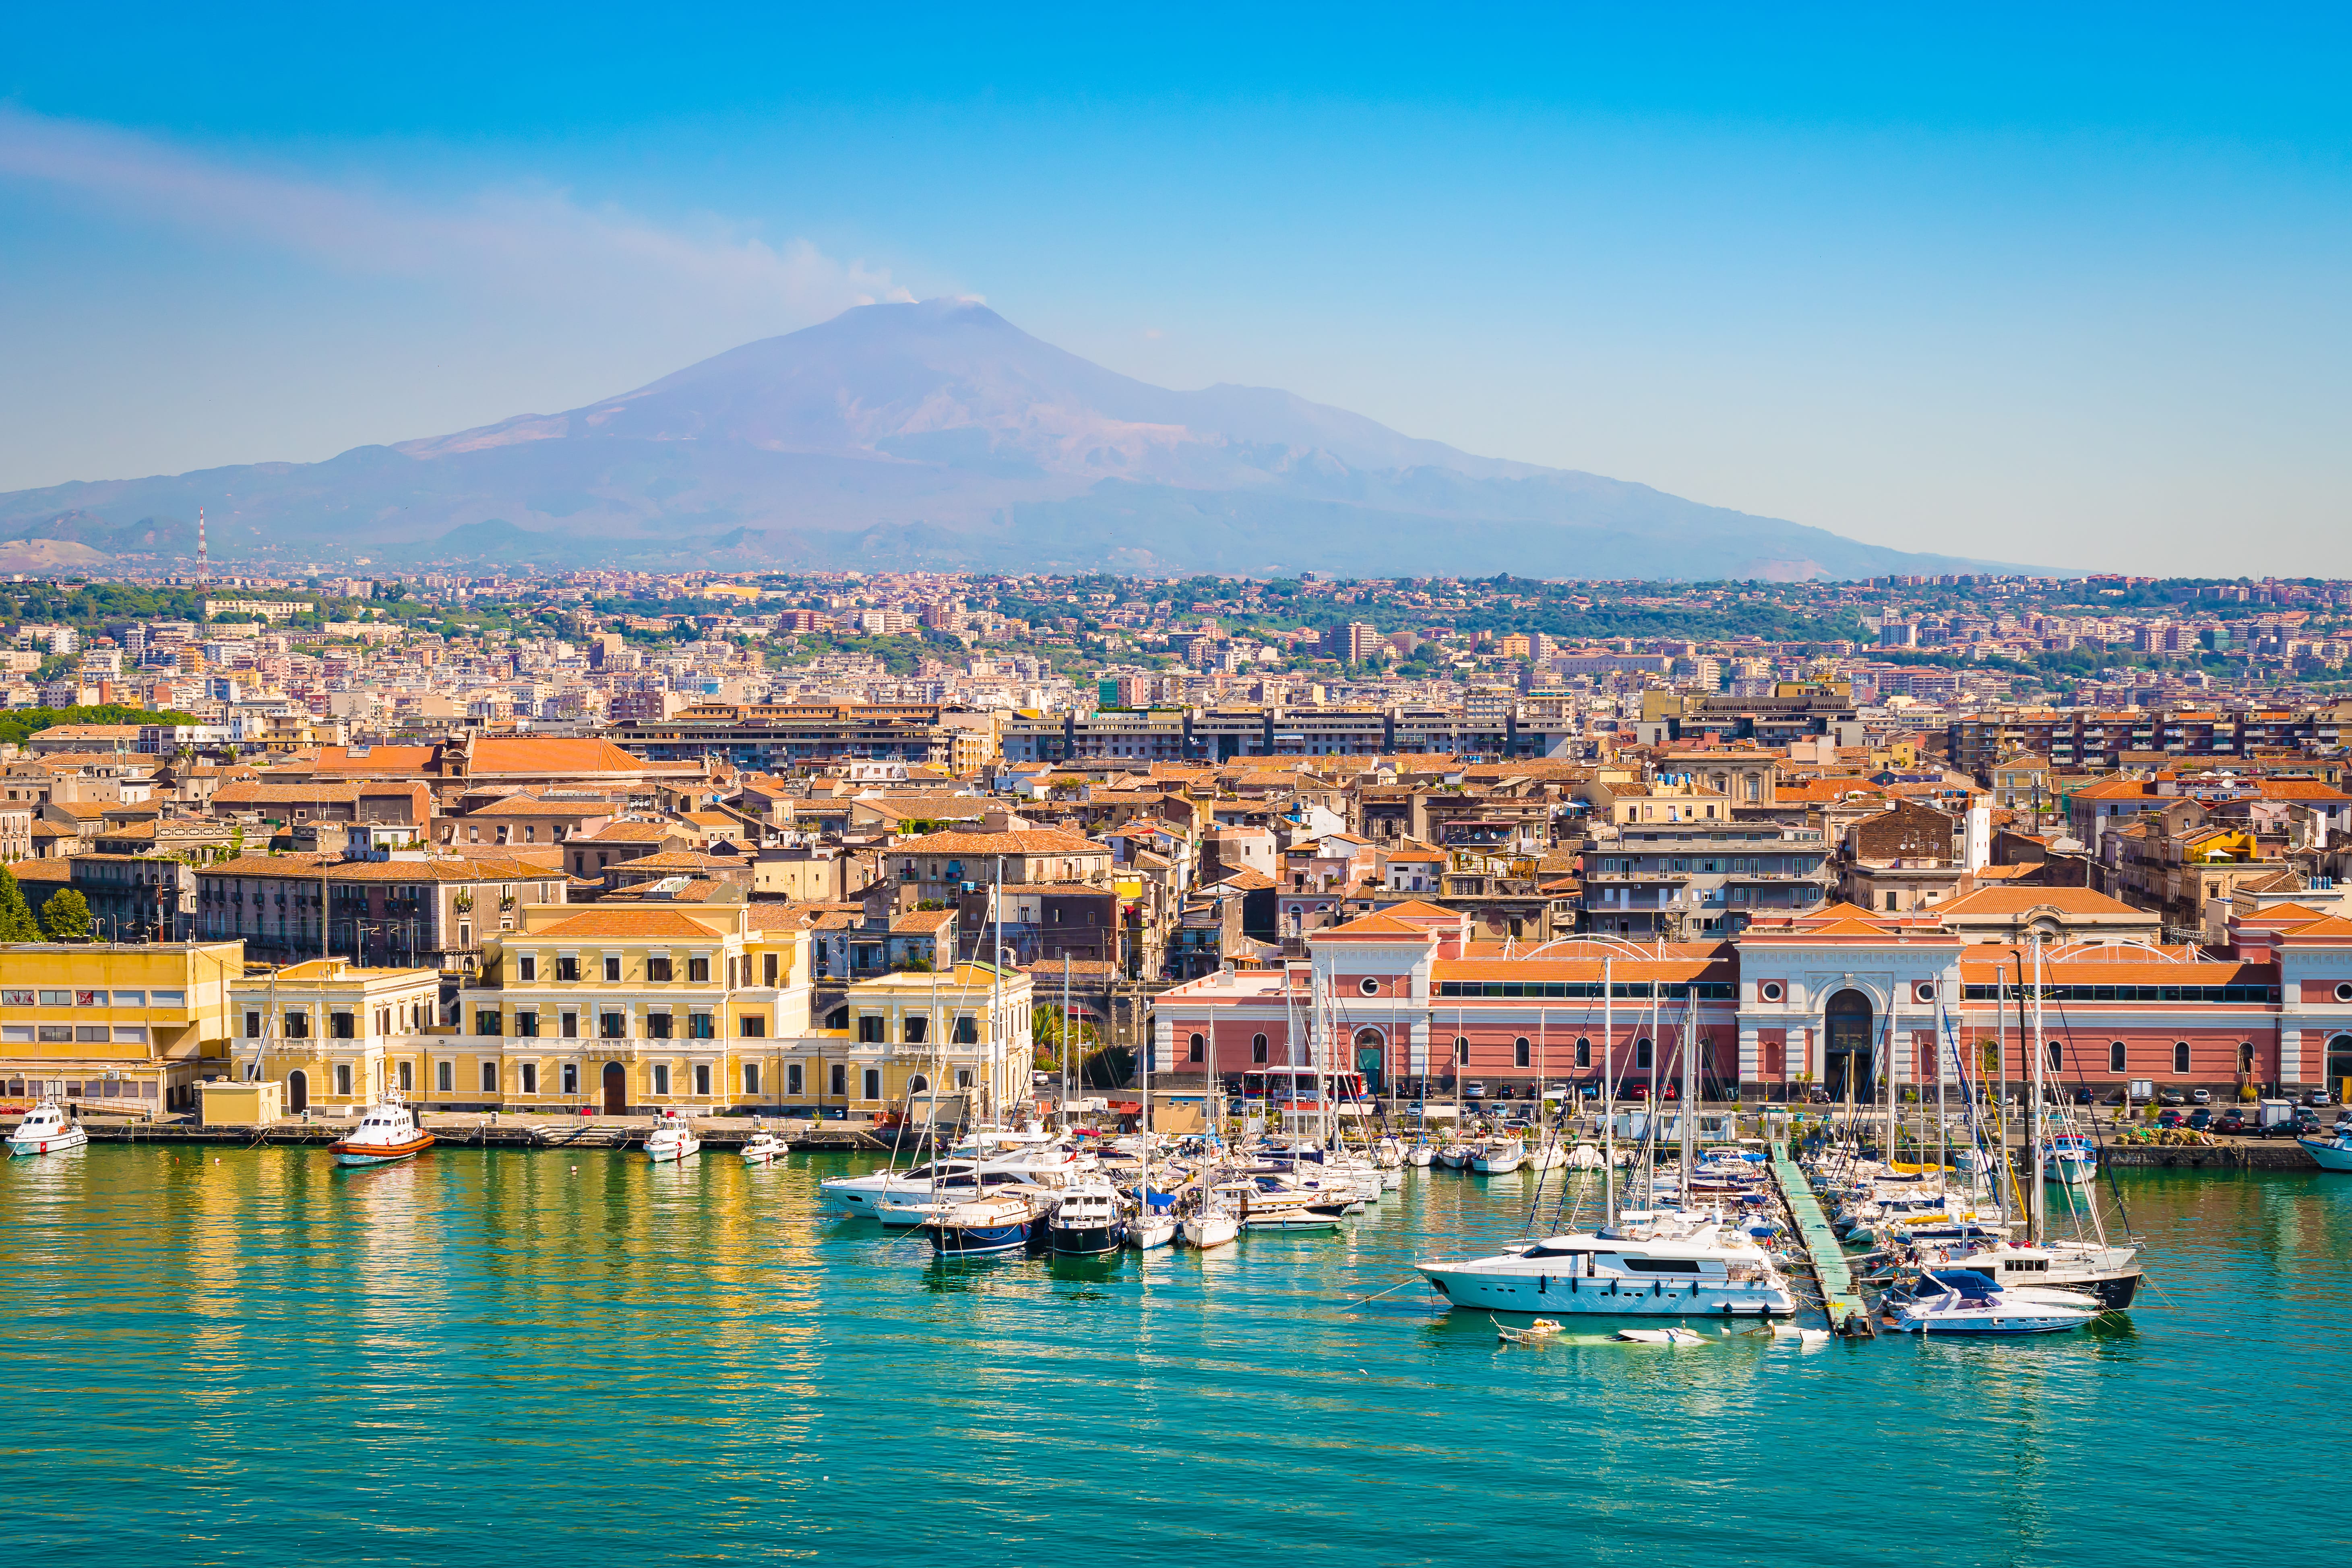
top-left (0, 943), bottom-right (245, 1114)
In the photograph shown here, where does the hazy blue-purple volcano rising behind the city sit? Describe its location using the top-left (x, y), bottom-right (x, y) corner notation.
top-left (0, 299), bottom-right (2032, 578)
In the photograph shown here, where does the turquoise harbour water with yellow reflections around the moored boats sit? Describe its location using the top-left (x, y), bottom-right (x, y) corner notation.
top-left (0, 1147), bottom-right (2352, 1568)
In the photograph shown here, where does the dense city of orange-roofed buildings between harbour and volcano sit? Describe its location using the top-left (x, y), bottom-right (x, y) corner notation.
top-left (0, 566), bottom-right (2352, 1119)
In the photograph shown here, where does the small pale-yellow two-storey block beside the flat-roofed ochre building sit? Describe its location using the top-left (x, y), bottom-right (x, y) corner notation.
top-left (228, 959), bottom-right (440, 1117)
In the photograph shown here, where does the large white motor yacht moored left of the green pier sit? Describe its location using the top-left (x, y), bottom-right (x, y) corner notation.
top-left (1414, 1215), bottom-right (1797, 1316)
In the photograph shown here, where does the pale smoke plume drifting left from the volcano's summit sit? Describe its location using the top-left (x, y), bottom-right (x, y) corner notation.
top-left (0, 108), bottom-right (913, 329)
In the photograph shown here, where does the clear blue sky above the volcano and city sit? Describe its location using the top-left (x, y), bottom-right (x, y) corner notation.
top-left (0, 5), bottom-right (2352, 576)
